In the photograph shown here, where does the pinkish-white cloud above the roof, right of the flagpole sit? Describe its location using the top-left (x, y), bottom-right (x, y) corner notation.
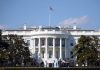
top-left (60, 16), bottom-right (89, 26)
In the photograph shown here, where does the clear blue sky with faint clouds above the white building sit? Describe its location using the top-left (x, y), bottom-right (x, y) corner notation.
top-left (0, 0), bottom-right (100, 29)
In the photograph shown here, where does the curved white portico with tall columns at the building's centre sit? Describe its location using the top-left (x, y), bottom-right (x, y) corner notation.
top-left (30, 31), bottom-right (68, 66)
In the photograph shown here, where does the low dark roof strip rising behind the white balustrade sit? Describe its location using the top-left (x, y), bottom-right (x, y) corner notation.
top-left (4, 26), bottom-right (95, 31)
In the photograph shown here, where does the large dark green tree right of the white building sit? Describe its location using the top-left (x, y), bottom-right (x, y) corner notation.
top-left (73, 35), bottom-right (100, 65)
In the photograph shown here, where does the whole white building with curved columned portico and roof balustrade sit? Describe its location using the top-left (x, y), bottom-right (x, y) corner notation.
top-left (2, 26), bottom-right (100, 67)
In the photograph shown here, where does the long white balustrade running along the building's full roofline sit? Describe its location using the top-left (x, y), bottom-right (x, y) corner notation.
top-left (2, 30), bottom-right (100, 35)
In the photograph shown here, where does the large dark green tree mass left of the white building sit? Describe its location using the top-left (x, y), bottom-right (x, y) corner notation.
top-left (0, 35), bottom-right (31, 66)
